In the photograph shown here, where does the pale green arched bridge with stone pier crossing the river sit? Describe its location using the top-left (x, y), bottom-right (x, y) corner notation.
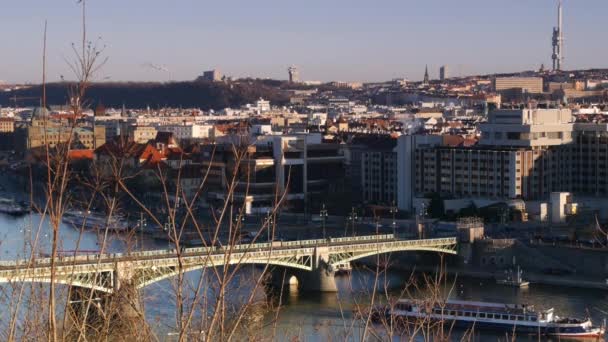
top-left (0, 234), bottom-right (456, 293)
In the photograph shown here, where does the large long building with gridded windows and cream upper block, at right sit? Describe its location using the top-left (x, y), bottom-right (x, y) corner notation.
top-left (398, 109), bottom-right (608, 209)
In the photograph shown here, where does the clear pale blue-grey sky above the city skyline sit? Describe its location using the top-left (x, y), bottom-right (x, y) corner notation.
top-left (0, 0), bottom-right (608, 83)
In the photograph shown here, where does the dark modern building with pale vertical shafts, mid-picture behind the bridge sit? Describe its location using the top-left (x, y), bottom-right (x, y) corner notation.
top-left (199, 134), bottom-right (344, 214)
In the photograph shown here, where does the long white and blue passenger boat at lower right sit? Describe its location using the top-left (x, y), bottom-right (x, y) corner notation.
top-left (372, 299), bottom-right (605, 339)
